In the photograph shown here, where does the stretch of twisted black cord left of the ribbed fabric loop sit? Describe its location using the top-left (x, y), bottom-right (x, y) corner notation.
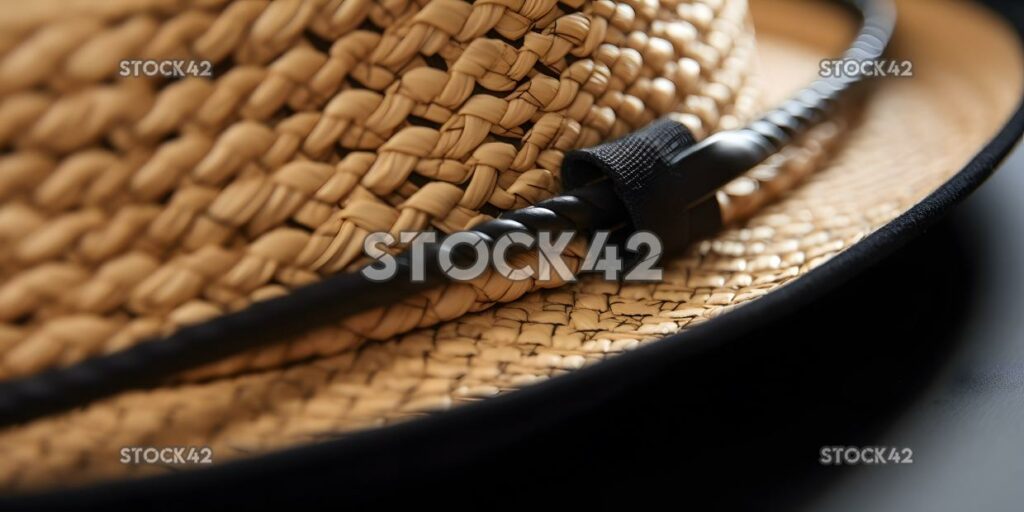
top-left (0, 183), bottom-right (626, 425)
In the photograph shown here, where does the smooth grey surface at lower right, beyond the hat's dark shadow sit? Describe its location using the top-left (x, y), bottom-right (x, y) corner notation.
top-left (812, 142), bottom-right (1024, 511)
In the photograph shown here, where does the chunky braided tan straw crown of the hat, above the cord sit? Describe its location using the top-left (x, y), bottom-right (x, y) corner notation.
top-left (0, 0), bottom-right (757, 378)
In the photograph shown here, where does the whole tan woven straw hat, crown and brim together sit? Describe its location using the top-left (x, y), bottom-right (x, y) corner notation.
top-left (0, 0), bottom-right (1024, 499)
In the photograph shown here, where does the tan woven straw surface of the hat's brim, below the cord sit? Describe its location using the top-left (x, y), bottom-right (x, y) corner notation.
top-left (0, 0), bottom-right (1022, 488)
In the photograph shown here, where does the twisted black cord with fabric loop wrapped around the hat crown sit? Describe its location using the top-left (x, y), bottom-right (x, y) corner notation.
top-left (0, 0), bottom-right (895, 425)
